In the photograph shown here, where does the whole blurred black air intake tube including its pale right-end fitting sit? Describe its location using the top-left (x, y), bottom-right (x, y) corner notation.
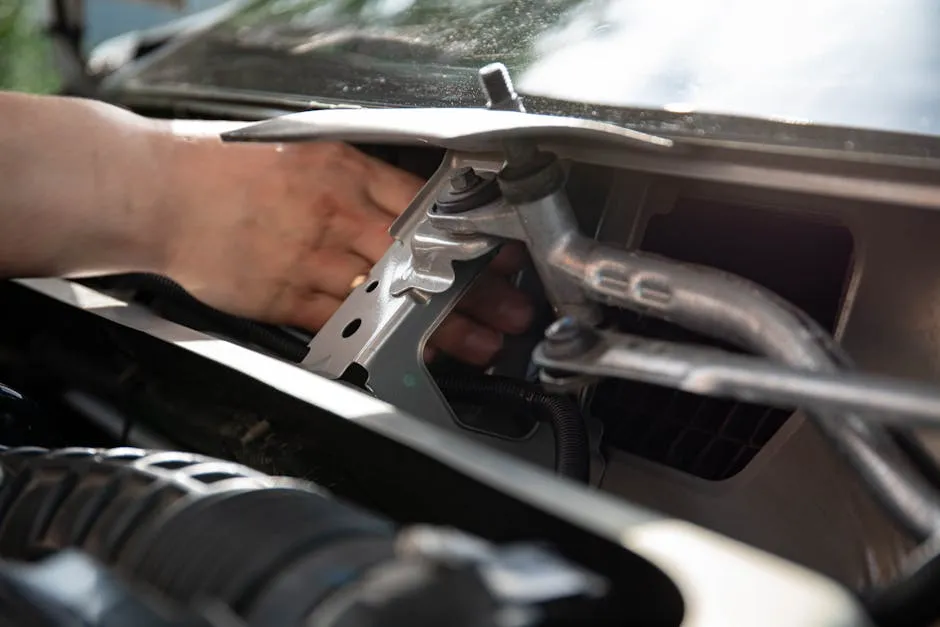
top-left (0, 448), bottom-right (605, 627)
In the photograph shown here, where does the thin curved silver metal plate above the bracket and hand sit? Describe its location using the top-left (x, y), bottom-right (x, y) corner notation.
top-left (222, 108), bottom-right (673, 152)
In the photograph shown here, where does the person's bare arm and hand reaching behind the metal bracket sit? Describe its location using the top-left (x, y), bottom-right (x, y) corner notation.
top-left (0, 92), bottom-right (531, 363)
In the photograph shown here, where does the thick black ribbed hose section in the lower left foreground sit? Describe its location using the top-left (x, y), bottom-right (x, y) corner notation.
top-left (0, 448), bottom-right (394, 627)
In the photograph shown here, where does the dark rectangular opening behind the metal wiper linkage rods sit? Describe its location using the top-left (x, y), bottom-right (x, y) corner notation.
top-left (589, 199), bottom-right (853, 481)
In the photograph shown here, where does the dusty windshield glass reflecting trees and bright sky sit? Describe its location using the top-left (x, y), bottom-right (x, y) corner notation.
top-left (121, 0), bottom-right (940, 139)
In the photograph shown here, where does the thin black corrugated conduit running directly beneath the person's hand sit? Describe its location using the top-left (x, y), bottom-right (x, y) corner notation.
top-left (92, 273), bottom-right (309, 363)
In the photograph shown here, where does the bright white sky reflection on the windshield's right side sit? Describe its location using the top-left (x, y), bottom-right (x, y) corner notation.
top-left (518, 0), bottom-right (940, 134)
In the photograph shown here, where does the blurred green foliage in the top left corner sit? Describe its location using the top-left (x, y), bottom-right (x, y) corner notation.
top-left (0, 0), bottom-right (58, 93)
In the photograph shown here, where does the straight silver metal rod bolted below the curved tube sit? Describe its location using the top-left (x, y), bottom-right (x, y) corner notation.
top-left (532, 332), bottom-right (940, 429)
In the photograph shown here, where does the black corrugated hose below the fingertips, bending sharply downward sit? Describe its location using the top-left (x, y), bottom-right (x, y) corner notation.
top-left (436, 375), bottom-right (591, 483)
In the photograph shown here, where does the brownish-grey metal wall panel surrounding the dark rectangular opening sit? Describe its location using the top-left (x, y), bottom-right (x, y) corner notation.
top-left (579, 171), bottom-right (912, 589)
